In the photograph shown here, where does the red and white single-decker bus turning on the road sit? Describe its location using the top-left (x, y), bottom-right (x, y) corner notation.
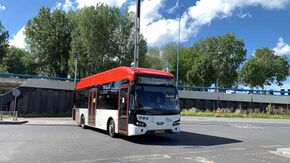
top-left (73, 66), bottom-right (180, 137)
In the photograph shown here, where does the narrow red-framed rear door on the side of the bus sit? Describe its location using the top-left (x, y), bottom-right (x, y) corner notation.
top-left (88, 89), bottom-right (97, 127)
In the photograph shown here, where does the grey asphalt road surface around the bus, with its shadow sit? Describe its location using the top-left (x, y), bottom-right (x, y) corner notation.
top-left (0, 117), bottom-right (290, 163)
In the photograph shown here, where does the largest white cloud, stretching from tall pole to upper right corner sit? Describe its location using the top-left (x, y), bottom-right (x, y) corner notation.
top-left (129, 0), bottom-right (290, 46)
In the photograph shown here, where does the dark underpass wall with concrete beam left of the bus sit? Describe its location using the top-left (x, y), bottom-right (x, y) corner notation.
top-left (0, 76), bottom-right (75, 116)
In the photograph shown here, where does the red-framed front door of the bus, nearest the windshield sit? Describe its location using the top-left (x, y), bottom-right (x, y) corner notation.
top-left (118, 86), bottom-right (129, 133)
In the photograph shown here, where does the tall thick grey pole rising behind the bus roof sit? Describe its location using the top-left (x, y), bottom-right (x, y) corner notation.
top-left (134, 0), bottom-right (141, 67)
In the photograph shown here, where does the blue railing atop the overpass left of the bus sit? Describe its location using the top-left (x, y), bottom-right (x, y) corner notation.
top-left (0, 74), bottom-right (79, 82)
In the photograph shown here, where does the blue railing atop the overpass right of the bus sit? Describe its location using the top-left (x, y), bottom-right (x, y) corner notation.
top-left (176, 86), bottom-right (290, 96)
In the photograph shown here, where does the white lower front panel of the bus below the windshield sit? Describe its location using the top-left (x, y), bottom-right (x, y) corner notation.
top-left (128, 115), bottom-right (180, 136)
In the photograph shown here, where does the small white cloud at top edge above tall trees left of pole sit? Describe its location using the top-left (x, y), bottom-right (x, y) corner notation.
top-left (76, 0), bottom-right (126, 8)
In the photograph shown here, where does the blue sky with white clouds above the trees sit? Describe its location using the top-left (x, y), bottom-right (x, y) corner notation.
top-left (0, 0), bottom-right (290, 89)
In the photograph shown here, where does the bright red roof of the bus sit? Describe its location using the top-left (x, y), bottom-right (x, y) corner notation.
top-left (76, 66), bottom-right (174, 89)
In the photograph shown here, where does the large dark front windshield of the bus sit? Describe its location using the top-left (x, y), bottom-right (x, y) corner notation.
top-left (135, 85), bottom-right (180, 113)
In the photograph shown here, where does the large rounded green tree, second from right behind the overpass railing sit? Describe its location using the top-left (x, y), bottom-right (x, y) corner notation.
top-left (187, 34), bottom-right (247, 87)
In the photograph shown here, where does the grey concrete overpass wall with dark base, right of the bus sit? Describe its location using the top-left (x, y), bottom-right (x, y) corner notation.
top-left (179, 90), bottom-right (290, 113)
